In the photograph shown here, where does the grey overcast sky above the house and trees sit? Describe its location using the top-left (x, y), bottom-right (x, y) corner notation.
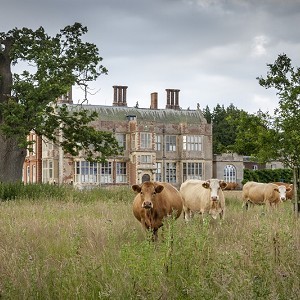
top-left (0, 0), bottom-right (300, 113)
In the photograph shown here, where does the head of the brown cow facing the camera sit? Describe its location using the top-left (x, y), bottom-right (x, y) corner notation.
top-left (132, 181), bottom-right (164, 209)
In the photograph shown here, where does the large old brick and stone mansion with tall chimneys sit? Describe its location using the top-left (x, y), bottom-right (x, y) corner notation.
top-left (23, 86), bottom-right (213, 188)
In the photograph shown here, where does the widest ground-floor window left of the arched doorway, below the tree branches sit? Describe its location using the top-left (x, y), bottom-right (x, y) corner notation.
top-left (75, 161), bottom-right (98, 183)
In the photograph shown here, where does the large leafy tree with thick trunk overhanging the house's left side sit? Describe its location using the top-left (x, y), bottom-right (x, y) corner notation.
top-left (0, 23), bottom-right (120, 182)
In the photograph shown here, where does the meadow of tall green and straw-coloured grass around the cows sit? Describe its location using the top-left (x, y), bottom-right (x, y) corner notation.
top-left (0, 186), bottom-right (300, 300)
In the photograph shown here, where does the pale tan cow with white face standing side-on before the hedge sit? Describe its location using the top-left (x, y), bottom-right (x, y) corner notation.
top-left (242, 181), bottom-right (290, 209)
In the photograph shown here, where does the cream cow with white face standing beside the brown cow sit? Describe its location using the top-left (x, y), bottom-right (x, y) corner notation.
top-left (180, 178), bottom-right (226, 221)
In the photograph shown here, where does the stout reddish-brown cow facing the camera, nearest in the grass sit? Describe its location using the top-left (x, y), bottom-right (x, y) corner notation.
top-left (132, 181), bottom-right (182, 240)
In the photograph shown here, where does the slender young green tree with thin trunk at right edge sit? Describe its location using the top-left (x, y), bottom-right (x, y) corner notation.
top-left (257, 54), bottom-right (300, 213)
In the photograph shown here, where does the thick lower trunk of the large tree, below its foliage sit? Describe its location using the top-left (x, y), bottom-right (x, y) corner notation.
top-left (0, 133), bottom-right (26, 182)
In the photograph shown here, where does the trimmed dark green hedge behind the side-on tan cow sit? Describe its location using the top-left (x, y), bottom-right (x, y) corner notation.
top-left (242, 169), bottom-right (293, 184)
